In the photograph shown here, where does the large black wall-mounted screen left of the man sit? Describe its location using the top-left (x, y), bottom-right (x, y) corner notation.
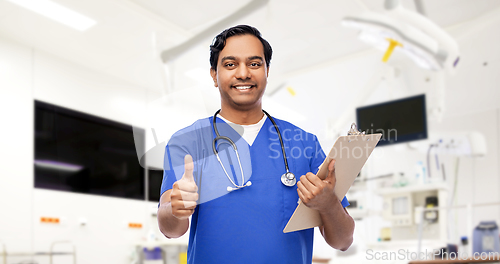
top-left (34, 101), bottom-right (145, 200)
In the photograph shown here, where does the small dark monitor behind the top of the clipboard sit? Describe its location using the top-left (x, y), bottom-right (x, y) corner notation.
top-left (356, 94), bottom-right (427, 146)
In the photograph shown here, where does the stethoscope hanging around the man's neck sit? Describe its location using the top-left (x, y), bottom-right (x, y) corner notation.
top-left (212, 109), bottom-right (297, 192)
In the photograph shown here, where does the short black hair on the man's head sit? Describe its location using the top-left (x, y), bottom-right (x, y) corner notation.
top-left (210, 25), bottom-right (273, 70)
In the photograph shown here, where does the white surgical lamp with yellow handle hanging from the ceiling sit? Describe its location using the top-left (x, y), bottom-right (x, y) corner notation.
top-left (342, 0), bottom-right (459, 71)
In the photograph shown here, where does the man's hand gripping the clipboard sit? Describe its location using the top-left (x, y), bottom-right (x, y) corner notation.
top-left (297, 160), bottom-right (337, 212)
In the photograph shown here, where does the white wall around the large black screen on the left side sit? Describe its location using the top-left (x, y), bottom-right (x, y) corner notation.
top-left (0, 34), bottom-right (170, 263)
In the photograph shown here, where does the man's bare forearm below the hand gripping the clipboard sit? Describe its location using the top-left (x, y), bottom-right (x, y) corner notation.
top-left (320, 201), bottom-right (354, 251)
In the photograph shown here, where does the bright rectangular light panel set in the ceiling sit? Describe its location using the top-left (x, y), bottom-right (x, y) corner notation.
top-left (7, 0), bottom-right (97, 31)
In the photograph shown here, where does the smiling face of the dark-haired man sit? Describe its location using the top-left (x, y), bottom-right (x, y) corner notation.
top-left (210, 35), bottom-right (269, 110)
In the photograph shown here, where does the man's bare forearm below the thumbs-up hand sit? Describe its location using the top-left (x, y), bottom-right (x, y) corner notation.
top-left (158, 203), bottom-right (189, 238)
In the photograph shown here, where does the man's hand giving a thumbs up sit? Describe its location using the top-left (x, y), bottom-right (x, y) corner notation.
top-left (170, 154), bottom-right (198, 219)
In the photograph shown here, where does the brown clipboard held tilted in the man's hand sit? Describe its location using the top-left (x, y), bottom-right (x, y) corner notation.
top-left (283, 123), bottom-right (382, 233)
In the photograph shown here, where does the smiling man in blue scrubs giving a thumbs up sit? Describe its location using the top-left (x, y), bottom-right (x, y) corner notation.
top-left (158, 25), bottom-right (354, 264)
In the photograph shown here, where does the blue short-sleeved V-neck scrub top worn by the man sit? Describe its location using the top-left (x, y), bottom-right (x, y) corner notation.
top-left (161, 117), bottom-right (349, 263)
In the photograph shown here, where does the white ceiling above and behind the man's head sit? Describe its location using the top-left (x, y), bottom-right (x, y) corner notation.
top-left (0, 0), bottom-right (500, 95)
